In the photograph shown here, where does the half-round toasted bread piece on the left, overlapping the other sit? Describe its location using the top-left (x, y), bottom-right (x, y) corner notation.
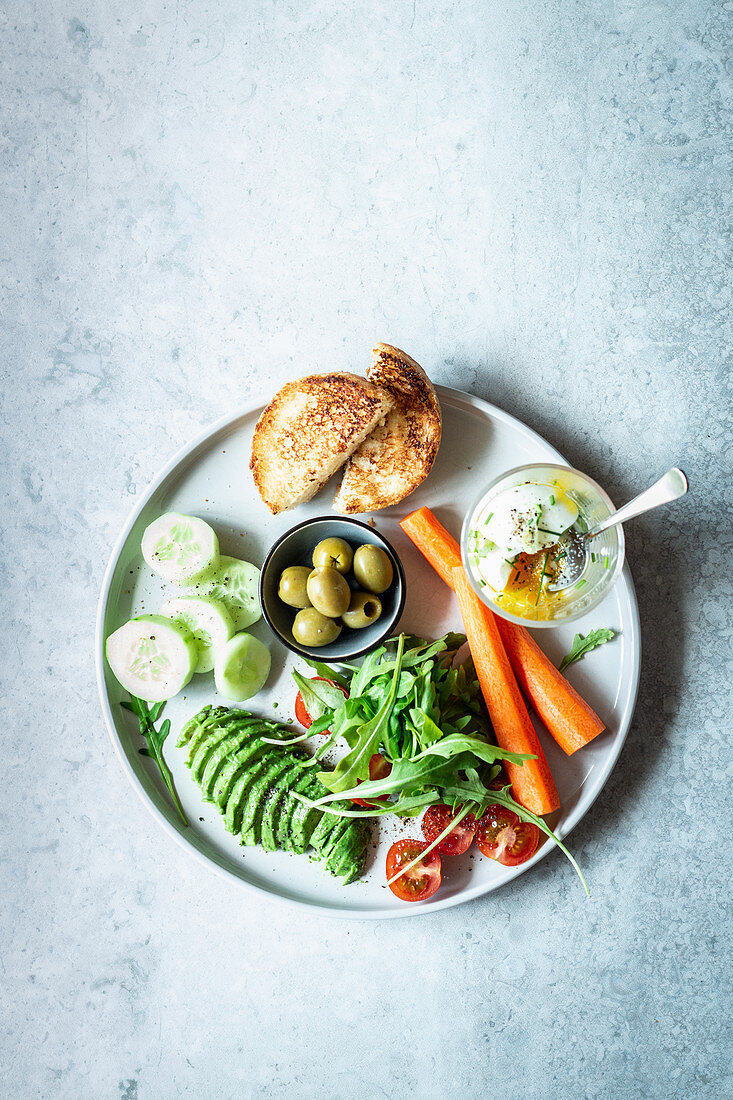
top-left (250, 372), bottom-right (393, 515)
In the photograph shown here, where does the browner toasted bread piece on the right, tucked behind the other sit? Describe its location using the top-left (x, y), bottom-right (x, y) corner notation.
top-left (333, 344), bottom-right (442, 514)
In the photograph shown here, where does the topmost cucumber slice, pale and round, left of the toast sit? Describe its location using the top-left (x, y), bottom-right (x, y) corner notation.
top-left (141, 512), bottom-right (219, 584)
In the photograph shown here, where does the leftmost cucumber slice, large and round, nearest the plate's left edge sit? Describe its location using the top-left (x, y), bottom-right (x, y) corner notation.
top-left (107, 615), bottom-right (197, 703)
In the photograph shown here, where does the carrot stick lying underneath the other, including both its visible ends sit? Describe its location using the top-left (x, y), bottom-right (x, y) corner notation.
top-left (400, 508), bottom-right (605, 755)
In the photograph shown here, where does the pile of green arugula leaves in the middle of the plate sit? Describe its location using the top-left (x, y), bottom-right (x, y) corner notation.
top-left (293, 631), bottom-right (585, 890)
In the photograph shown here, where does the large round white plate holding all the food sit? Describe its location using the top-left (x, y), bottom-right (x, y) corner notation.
top-left (96, 387), bottom-right (639, 919)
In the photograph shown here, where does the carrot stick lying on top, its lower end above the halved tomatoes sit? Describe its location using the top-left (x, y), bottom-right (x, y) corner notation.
top-left (452, 567), bottom-right (560, 814)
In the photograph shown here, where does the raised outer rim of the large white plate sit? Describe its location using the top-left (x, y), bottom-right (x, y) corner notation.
top-left (95, 385), bottom-right (642, 921)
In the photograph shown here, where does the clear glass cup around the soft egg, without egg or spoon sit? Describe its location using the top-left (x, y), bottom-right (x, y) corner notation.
top-left (461, 462), bottom-right (624, 627)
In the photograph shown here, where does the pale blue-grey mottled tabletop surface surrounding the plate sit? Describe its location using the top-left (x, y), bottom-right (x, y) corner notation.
top-left (0, 0), bottom-right (733, 1100)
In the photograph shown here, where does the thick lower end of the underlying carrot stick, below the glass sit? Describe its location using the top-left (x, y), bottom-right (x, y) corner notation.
top-left (496, 615), bottom-right (605, 756)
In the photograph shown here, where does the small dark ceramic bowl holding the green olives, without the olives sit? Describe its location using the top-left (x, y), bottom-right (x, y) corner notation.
top-left (260, 516), bottom-right (407, 662)
